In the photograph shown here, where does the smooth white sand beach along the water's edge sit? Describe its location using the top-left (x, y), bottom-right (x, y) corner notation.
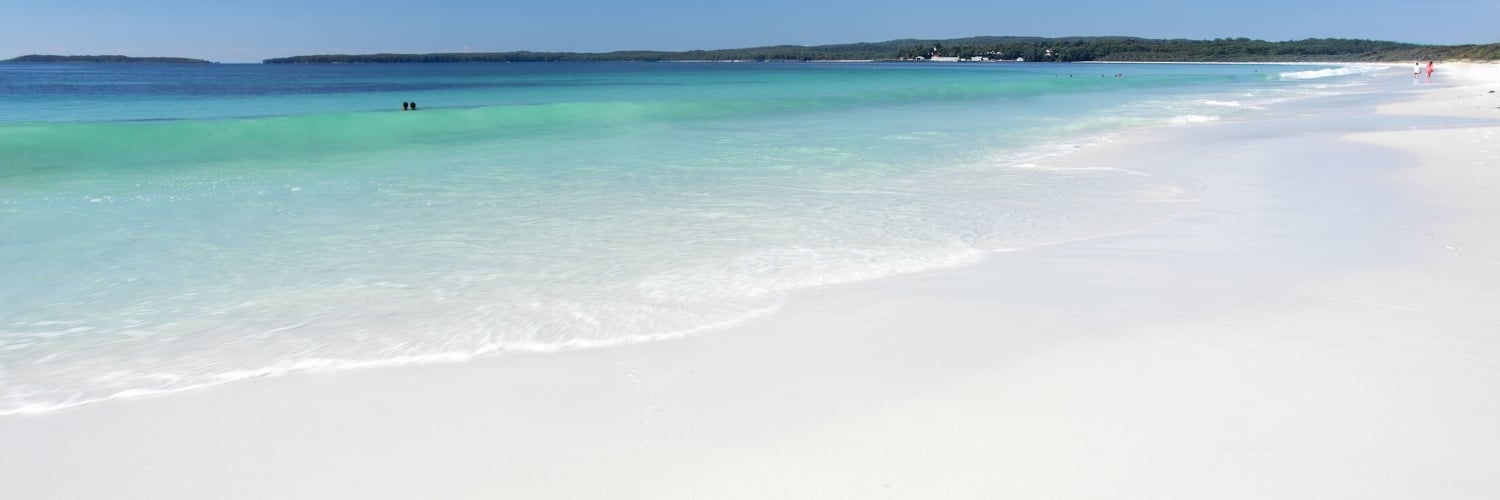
top-left (0, 63), bottom-right (1500, 500)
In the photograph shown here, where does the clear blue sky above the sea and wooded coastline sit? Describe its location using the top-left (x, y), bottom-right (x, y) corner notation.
top-left (0, 0), bottom-right (1500, 62)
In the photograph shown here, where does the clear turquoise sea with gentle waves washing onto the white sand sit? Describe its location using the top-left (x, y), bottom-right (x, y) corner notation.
top-left (0, 63), bottom-right (1368, 414)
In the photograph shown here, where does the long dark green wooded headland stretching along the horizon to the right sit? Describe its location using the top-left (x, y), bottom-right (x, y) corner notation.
top-left (264, 36), bottom-right (1500, 65)
